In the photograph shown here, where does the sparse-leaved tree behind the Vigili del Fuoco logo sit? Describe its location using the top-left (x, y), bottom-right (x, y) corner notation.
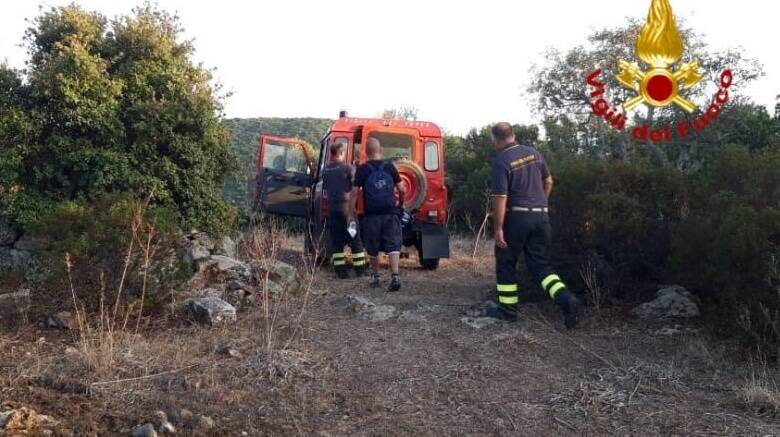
top-left (527, 21), bottom-right (763, 166)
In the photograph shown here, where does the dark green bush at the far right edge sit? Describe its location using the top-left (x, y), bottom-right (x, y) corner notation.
top-left (670, 146), bottom-right (780, 351)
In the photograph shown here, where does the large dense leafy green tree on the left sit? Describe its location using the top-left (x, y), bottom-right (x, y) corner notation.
top-left (0, 5), bottom-right (236, 232)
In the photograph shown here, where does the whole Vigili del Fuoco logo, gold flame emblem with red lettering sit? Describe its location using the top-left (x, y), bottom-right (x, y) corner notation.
top-left (586, 0), bottom-right (733, 142)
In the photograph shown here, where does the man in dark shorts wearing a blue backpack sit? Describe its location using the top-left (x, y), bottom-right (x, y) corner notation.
top-left (352, 137), bottom-right (406, 291)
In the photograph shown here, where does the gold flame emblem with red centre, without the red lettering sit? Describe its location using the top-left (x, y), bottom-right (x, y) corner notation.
top-left (616, 0), bottom-right (702, 112)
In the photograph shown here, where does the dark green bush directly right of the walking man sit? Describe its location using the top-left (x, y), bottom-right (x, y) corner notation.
top-left (550, 159), bottom-right (686, 288)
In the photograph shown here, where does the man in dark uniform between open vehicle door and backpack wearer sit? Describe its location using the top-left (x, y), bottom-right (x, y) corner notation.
top-left (322, 143), bottom-right (366, 279)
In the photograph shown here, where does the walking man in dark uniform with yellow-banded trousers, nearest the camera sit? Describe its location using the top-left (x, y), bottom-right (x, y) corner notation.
top-left (487, 123), bottom-right (579, 329)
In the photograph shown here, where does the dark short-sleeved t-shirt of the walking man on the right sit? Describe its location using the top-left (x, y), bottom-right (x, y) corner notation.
top-left (490, 144), bottom-right (550, 208)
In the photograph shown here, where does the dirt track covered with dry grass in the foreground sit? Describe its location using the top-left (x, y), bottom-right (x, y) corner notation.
top-left (0, 240), bottom-right (780, 436)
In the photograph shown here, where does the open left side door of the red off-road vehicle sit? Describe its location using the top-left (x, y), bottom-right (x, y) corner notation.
top-left (253, 135), bottom-right (314, 217)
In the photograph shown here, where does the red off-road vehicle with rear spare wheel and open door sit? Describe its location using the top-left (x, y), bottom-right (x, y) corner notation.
top-left (253, 112), bottom-right (449, 270)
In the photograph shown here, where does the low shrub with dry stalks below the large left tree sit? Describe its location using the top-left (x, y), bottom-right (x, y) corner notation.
top-left (30, 196), bottom-right (193, 310)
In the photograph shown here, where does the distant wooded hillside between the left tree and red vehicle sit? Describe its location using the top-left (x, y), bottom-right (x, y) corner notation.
top-left (223, 118), bottom-right (332, 209)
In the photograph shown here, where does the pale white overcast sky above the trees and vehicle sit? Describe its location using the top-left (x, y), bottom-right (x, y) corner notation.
top-left (0, 0), bottom-right (780, 134)
